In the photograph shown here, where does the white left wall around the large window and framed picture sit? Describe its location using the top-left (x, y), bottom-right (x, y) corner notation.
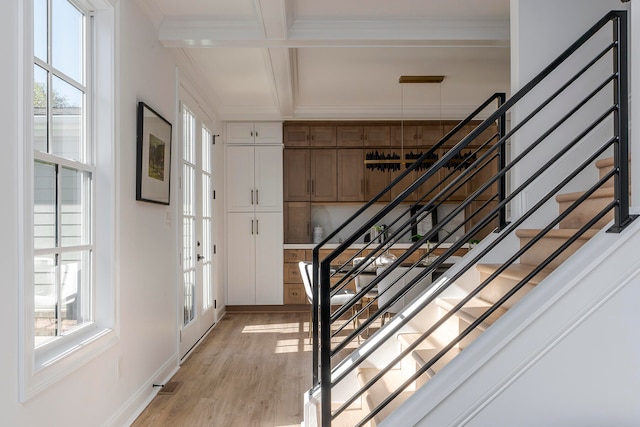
top-left (0, 0), bottom-right (220, 426)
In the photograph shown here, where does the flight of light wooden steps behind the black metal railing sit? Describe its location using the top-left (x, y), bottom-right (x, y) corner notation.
top-left (348, 158), bottom-right (614, 426)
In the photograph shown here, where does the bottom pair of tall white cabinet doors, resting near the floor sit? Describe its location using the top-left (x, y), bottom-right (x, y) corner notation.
top-left (227, 212), bottom-right (284, 305)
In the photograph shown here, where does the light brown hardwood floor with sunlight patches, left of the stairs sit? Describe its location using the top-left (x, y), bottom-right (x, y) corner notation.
top-left (132, 313), bottom-right (311, 427)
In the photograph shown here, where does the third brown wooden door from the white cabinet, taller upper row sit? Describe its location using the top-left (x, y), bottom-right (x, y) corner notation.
top-left (338, 148), bottom-right (364, 202)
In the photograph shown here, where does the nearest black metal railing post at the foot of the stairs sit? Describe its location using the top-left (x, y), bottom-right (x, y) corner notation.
top-left (319, 260), bottom-right (331, 427)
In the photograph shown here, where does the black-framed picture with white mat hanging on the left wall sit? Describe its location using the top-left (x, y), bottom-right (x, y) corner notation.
top-left (136, 102), bottom-right (172, 205)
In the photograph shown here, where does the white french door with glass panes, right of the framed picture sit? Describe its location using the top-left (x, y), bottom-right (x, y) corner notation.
top-left (179, 104), bottom-right (215, 359)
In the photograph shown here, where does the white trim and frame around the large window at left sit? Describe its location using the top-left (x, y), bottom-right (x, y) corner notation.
top-left (17, 0), bottom-right (119, 402)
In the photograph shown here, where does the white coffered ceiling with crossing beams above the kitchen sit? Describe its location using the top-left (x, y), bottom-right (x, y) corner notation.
top-left (138, 0), bottom-right (510, 120)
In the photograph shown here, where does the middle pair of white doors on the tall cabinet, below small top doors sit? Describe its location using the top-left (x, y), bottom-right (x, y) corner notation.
top-left (226, 145), bottom-right (282, 212)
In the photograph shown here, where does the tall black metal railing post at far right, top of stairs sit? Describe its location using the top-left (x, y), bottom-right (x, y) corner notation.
top-left (607, 12), bottom-right (636, 233)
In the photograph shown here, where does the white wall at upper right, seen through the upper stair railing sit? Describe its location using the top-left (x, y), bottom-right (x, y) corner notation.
top-left (511, 0), bottom-right (630, 221)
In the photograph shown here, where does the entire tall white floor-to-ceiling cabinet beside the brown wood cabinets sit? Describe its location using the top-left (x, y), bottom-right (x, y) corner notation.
top-left (225, 128), bottom-right (284, 305)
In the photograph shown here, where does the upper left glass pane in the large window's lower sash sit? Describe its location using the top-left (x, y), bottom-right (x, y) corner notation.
top-left (33, 162), bottom-right (56, 249)
